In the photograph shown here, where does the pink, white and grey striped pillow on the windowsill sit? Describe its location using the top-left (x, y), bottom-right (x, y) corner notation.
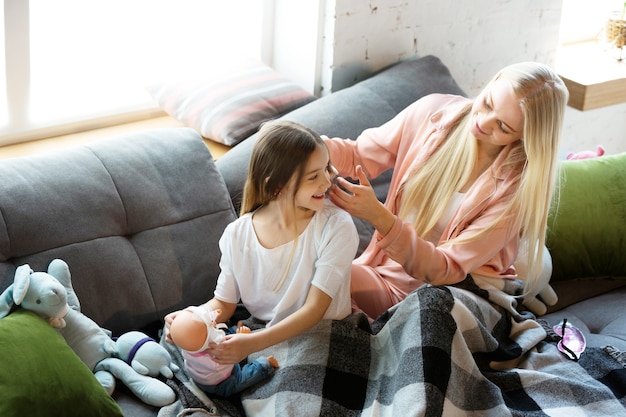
top-left (147, 61), bottom-right (315, 146)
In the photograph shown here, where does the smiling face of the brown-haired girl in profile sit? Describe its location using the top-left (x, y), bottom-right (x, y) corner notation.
top-left (287, 145), bottom-right (334, 211)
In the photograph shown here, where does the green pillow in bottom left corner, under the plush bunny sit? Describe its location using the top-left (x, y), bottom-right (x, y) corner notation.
top-left (0, 310), bottom-right (123, 417)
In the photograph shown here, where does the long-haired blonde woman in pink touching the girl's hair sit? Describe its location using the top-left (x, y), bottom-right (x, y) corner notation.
top-left (324, 62), bottom-right (568, 318)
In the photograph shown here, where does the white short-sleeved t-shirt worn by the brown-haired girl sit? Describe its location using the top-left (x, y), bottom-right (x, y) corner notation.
top-left (215, 203), bottom-right (359, 327)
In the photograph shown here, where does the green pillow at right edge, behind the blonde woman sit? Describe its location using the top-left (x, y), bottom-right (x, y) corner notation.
top-left (547, 153), bottom-right (626, 281)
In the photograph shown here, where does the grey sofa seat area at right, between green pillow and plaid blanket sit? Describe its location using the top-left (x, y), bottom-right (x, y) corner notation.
top-left (541, 283), bottom-right (626, 352)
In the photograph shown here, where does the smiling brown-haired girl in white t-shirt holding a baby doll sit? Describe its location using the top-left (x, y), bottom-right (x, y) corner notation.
top-left (165, 121), bottom-right (358, 364)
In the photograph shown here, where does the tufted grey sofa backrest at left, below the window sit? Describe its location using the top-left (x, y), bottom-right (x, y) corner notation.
top-left (0, 128), bottom-right (236, 334)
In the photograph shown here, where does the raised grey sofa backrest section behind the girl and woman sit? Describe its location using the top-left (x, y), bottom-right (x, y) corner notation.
top-left (216, 55), bottom-right (465, 253)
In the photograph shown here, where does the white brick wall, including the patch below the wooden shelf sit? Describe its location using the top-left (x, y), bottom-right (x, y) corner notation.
top-left (276, 0), bottom-right (626, 157)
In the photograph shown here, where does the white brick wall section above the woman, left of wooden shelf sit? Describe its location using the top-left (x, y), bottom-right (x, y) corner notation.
top-left (323, 0), bottom-right (562, 96)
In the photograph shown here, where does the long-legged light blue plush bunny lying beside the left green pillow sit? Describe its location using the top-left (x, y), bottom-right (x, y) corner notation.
top-left (0, 259), bottom-right (177, 407)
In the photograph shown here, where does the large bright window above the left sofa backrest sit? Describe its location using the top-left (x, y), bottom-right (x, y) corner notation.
top-left (0, 0), bottom-right (267, 144)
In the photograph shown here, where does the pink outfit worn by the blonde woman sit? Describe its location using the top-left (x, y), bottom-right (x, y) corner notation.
top-left (326, 94), bottom-right (522, 317)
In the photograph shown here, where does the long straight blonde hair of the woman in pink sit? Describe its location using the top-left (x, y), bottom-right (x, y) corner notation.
top-left (400, 62), bottom-right (569, 292)
